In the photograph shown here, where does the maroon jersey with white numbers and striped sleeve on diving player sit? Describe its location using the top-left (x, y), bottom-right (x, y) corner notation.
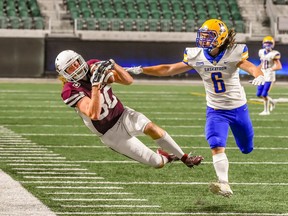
top-left (61, 60), bottom-right (124, 135)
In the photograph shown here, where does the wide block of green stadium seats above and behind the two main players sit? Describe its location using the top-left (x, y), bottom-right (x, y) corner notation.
top-left (64, 0), bottom-right (245, 32)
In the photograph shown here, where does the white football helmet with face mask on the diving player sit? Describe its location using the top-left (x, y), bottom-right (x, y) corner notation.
top-left (55, 50), bottom-right (89, 82)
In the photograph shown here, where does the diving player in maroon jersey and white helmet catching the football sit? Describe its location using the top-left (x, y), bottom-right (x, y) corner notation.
top-left (55, 50), bottom-right (203, 168)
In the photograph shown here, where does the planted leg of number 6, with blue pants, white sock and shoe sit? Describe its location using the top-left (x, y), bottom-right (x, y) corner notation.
top-left (205, 107), bottom-right (233, 197)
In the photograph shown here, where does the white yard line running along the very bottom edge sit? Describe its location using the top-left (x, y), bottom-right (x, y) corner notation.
top-left (56, 212), bottom-right (288, 216)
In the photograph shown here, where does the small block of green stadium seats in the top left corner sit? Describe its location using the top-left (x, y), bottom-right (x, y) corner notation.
top-left (0, 0), bottom-right (45, 29)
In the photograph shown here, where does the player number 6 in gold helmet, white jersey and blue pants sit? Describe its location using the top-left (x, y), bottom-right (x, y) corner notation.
top-left (126, 19), bottom-right (264, 197)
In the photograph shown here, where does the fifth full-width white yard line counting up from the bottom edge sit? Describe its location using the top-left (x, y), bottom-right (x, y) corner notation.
top-left (12, 133), bottom-right (288, 139)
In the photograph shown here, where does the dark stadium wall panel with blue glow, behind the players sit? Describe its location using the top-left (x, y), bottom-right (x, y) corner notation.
top-left (45, 38), bottom-right (288, 79)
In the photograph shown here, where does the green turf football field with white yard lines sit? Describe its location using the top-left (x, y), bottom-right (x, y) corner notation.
top-left (0, 83), bottom-right (288, 216)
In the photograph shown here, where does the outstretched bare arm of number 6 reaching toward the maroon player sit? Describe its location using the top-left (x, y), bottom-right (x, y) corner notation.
top-left (142, 62), bottom-right (192, 76)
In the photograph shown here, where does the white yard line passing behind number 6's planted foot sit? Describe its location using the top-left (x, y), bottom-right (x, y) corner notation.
top-left (21, 181), bottom-right (288, 186)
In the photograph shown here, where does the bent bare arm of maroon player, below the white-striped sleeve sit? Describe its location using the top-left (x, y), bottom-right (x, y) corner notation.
top-left (76, 84), bottom-right (101, 120)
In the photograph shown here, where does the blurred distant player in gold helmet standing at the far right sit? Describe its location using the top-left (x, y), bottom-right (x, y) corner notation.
top-left (256, 36), bottom-right (282, 115)
